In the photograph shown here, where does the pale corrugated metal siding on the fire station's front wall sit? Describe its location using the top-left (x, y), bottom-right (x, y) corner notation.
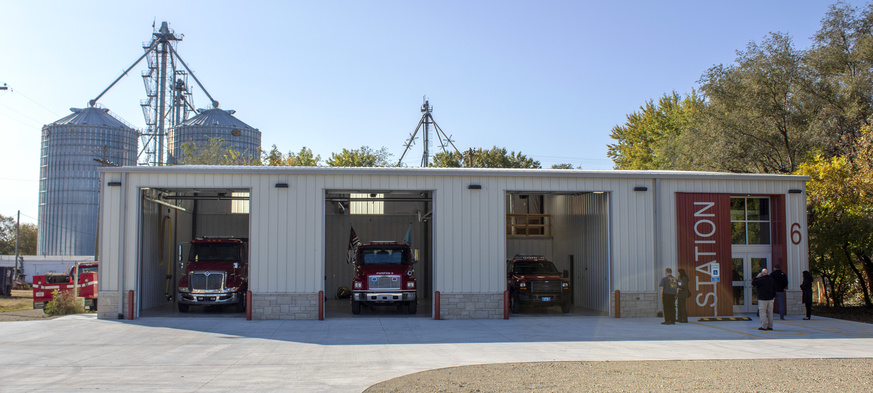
top-left (101, 167), bottom-right (805, 316)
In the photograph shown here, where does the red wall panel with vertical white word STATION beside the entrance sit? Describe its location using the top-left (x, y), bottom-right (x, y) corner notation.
top-left (674, 193), bottom-right (733, 317)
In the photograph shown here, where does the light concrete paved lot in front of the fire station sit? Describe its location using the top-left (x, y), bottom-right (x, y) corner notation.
top-left (0, 313), bottom-right (873, 392)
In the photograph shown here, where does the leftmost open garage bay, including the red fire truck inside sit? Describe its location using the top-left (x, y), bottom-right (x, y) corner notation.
top-left (136, 188), bottom-right (250, 318)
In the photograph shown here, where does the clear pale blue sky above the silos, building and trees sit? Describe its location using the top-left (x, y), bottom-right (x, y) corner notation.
top-left (0, 0), bottom-right (864, 224)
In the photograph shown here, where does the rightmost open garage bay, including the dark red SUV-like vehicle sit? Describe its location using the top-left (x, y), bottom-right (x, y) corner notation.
top-left (505, 191), bottom-right (610, 315)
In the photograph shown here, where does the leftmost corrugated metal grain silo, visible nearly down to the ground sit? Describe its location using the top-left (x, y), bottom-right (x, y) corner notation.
top-left (37, 106), bottom-right (138, 255)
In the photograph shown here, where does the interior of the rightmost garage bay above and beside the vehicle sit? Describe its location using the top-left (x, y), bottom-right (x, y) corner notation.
top-left (506, 190), bottom-right (611, 312)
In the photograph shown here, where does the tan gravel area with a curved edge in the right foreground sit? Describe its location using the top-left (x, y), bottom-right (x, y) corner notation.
top-left (364, 359), bottom-right (873, 393)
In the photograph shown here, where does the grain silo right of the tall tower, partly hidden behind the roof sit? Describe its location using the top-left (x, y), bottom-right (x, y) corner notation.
top-left (167, 108), bottom-right (261, 164)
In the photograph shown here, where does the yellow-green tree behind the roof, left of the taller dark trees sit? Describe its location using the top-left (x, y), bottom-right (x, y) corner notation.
top-left (606, 91), bottom-right (704, 170)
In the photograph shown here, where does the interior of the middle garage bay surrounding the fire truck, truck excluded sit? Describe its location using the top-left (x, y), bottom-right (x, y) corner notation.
top-left (324, 190), bottom-right (433, 316)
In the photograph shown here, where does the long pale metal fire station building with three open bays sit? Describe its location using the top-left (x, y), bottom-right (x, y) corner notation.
top-left (98, 166), bottom-right (809, 319)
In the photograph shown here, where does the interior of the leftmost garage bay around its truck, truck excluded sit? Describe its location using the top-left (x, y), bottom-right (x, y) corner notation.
top-left (136, 188), bottom-right (250, 316)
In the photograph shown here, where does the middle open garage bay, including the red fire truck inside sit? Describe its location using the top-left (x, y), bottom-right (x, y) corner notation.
top-left (324, 190), bottom-right (433, 318)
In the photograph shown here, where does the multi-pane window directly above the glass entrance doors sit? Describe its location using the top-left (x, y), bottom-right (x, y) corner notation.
top-left (731, 197), bottom-right (770, 245)
